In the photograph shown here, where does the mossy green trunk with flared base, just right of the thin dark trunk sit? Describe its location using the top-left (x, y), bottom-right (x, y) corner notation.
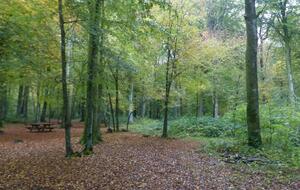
top-left (84, 0), bottom-right (101, 154)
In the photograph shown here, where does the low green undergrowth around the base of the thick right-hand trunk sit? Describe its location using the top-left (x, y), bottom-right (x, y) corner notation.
top-left (129, 117), bottom-right (300, 169)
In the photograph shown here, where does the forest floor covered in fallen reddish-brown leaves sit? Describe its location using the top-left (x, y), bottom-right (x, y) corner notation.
top-left (0, 123), bottom-right (300, 190)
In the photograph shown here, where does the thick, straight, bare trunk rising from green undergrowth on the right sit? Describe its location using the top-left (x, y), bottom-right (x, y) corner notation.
top-left (245, 0), bottom-right (262, 147)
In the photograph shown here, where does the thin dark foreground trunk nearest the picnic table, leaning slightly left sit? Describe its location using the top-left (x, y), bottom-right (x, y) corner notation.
top-left (58, 0), bottom-right (73, 157)
